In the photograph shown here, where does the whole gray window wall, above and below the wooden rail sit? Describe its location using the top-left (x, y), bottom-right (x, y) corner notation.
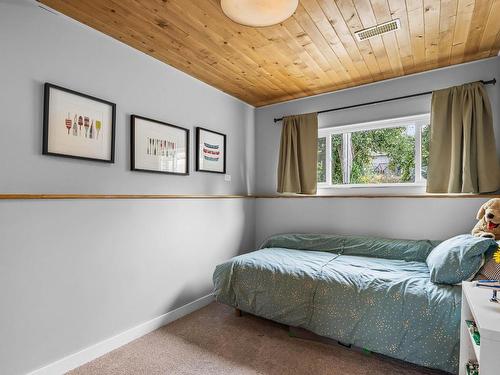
top-left (255, 57), bottom-right (500, 247)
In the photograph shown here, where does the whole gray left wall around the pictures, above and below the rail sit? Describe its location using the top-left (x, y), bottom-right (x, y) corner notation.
top-left (0, 1), bottom-right (255, 375)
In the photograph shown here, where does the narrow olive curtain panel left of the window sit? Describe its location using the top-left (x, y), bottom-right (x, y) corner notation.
top-left (278, 113), bottom-right (318, 194)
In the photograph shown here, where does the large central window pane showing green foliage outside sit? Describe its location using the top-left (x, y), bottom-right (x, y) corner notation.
top-left (348, 126), bottom-right (415, 184)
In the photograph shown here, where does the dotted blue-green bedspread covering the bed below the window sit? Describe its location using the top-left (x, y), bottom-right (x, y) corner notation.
top-left (214, 235), bottom-right (461, 373)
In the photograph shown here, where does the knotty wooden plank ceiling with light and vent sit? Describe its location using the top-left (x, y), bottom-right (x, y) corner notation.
top-left (40, 0), bottom-right (500, 106)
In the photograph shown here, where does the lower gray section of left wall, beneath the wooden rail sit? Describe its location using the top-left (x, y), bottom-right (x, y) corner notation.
top-left (0, 199), bottom-right (255, 375)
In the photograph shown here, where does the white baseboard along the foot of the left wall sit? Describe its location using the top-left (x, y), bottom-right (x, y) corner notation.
top-left (28, 294), bottom-right (214, 375)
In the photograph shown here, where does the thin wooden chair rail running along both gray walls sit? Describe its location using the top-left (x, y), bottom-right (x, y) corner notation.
top-left (0, 194), bottom-right (500, 200)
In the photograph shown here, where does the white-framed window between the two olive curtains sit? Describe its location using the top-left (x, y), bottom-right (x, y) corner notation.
top-left (318, 114), bottom-right (430, 188)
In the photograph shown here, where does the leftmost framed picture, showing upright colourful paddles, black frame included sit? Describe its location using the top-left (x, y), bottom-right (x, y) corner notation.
top-left (42, 83), bottom-right (116, 163)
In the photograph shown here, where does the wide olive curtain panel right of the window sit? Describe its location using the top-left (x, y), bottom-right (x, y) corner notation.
top-left (427, 82), bottom-right (500, 193)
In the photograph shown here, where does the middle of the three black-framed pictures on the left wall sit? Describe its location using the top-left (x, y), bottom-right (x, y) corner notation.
top-left (130, 115), bottom-right (189, 175)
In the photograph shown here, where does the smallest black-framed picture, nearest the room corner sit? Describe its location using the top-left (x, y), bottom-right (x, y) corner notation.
top-left (196, 127), bottom-right (226, 173)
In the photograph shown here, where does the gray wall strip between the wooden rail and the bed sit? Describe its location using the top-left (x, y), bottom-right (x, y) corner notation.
top-left (255, 198), bottom-right (486, 244)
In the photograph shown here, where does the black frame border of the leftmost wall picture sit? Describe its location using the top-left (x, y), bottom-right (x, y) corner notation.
top-left (42, 82), bottom-right (116, 164)
